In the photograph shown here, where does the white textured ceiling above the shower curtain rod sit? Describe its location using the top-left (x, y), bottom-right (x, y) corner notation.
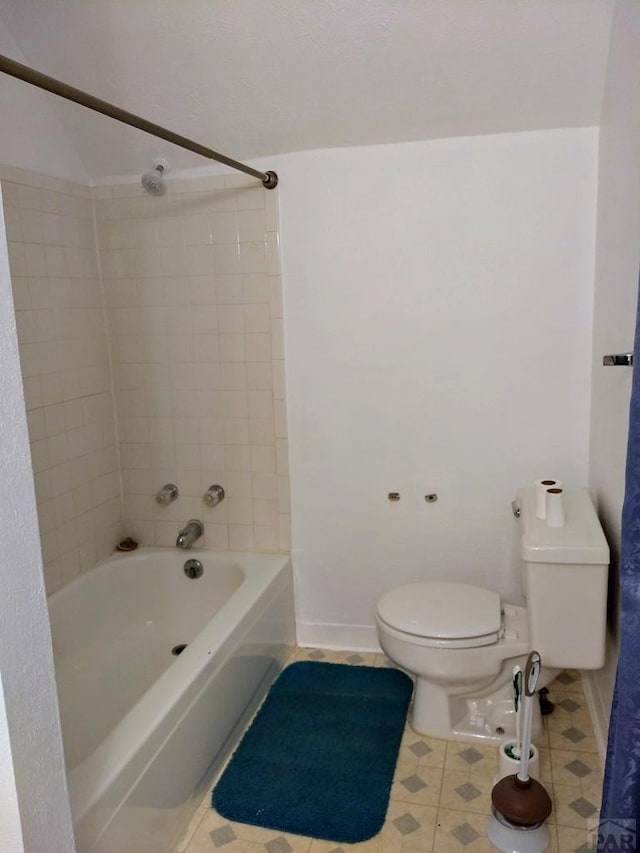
top-left (0, 0), bottom-right (615, 178)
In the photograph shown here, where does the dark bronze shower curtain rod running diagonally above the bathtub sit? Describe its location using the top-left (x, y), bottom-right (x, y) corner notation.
top-left (0, 54), bottom-right (278, 190)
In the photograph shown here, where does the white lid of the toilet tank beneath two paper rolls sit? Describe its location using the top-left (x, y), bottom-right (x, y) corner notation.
top-left (516, 486), bottom-right (609, 565)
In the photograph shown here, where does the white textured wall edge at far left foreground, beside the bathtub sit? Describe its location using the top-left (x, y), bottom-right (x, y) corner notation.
top-left (0, 190), bottom-right (74, 853)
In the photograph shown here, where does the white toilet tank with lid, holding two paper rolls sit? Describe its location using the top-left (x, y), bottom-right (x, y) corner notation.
top-left (516, 486), bottom-right (609, 669)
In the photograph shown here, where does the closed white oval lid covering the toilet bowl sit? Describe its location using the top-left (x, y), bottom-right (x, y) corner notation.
top-left (378, 581), bottom-right (501, 640)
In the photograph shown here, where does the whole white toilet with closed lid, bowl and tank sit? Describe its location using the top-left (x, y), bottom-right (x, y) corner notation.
top-left (376, 487), bottom-right (609, 742)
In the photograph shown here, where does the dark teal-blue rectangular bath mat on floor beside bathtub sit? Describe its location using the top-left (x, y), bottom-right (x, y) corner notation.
top-left (212, 661), bottom-right (412, 844)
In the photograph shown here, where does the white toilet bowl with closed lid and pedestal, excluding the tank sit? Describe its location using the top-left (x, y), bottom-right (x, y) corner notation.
top-left (376, 581), bottom-right (553, 743)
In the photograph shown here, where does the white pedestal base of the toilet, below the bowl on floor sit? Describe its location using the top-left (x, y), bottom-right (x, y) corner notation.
top-left (410, 676), bottom-right (542, 744)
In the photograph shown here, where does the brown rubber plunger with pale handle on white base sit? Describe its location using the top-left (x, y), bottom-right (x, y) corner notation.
top-left (487, 651), bottom-right (552, 853)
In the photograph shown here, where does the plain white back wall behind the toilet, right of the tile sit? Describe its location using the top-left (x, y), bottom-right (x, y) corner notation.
top-left (276, 129), bottom-right (598, 647)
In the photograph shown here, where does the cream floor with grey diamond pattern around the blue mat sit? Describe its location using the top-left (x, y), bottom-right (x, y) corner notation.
top-left (175, 649), bottom-right (602, 853)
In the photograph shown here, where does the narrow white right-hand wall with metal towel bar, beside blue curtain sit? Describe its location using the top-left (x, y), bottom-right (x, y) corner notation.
top-left (590, 0), bottom-right (640, 744)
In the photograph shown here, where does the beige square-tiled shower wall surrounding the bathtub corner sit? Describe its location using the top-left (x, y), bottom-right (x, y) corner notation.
top-left (0, 166), bottom-right (290, 594)
